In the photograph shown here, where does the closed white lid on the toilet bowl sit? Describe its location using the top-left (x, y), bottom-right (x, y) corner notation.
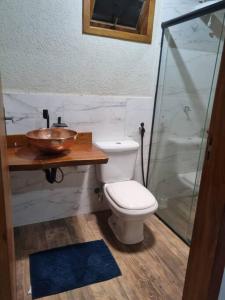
top-left (106, 180), bottom-right (156, 209)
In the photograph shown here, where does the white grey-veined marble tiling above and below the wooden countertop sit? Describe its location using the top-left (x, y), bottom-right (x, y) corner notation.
top-left (4, 93), bottom-right (153, 226)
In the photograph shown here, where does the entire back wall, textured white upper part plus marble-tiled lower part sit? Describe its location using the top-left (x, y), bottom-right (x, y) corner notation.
top-left (0, 0), bottom-right (198, 225)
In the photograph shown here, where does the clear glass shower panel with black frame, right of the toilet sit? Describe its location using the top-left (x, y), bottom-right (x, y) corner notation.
top-left (148, 5), bottom-right (225, 242)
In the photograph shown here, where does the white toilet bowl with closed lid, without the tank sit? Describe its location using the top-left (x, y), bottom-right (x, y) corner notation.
top-left (103, 180), bottom-right (158, 244)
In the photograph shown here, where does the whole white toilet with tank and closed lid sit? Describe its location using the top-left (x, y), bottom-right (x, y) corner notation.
top-left (96, 140), bottom-right (158, 244)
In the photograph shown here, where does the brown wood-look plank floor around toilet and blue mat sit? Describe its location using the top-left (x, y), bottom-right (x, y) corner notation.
top-left (15, 211), bottom-right (189, 300)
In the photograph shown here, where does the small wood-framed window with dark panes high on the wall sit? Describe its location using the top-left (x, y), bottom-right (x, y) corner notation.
top-left (83, 0), bottom-right (155, 43)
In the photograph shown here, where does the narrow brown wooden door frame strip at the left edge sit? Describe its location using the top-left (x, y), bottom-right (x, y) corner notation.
top-left (0, 78), bottom-right (16, 300)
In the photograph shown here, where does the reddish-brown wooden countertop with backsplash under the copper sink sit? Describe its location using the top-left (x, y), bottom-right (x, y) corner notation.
top-left (7, 132), bottom-right (108, 171)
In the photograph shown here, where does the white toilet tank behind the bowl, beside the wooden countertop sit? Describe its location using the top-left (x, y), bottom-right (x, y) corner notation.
top-left (95, 140), bottom-right (139, 183)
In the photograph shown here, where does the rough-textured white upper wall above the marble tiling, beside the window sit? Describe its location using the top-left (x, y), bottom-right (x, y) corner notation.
top-left (0, 0), bottom-right (160, 96)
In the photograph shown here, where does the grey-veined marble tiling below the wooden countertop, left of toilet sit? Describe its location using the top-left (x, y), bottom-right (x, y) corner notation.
top-left (12, 167), bottom-right (106, 225)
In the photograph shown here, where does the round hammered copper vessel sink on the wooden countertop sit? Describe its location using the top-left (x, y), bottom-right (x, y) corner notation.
top-left (26, 128), bottom-right (77, 154)
